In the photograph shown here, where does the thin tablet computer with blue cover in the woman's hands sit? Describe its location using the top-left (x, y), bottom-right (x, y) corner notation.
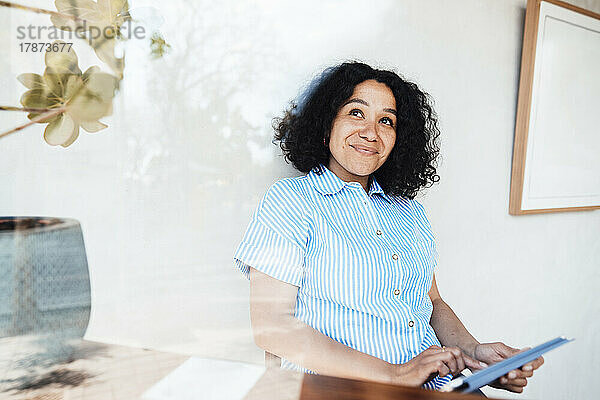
top-left (440, 337), bottom-right (575, 393)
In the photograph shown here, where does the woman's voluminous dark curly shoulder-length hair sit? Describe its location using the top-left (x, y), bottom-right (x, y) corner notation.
top-left (273, 62), bottom-right (440, 199)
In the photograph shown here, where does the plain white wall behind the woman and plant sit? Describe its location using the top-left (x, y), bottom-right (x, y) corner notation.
top-left (0, 0), bottom-right (600, 399)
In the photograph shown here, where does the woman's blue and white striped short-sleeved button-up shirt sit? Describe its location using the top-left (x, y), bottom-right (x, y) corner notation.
top-left (234, 165), bottom-right (451, 389)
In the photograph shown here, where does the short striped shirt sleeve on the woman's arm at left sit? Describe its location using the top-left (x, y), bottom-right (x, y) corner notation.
top-left (233, 178), bottom-right (308, 286)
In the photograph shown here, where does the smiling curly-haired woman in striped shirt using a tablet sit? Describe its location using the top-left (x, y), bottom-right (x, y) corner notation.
top-left (234, 62), bottom-right (543, 392)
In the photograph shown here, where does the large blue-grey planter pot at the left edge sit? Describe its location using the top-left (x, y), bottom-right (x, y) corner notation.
top-left (0, 217), bottom-right (91, 341)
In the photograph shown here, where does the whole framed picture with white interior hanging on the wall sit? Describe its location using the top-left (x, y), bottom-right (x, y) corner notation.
top-left (509, 0), bottom-right (600, 215)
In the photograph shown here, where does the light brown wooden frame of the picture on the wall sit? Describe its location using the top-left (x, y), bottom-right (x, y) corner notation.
top-left (509, 0), bottom-right (600, 215)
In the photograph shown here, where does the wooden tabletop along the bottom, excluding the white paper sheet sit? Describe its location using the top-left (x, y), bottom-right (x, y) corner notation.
top-left (0, 337), bottom-right (492, 400)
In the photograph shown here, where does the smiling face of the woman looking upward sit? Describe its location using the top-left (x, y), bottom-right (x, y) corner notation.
top-left (328, 79), bottom-right (396, 182)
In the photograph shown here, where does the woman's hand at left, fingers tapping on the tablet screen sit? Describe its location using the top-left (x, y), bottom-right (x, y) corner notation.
top-left (392, 346), bottom-right (481, 386)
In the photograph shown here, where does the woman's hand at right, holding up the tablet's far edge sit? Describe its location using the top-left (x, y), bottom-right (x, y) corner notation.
top-left (473, 342), bottom-right (544, 393)
